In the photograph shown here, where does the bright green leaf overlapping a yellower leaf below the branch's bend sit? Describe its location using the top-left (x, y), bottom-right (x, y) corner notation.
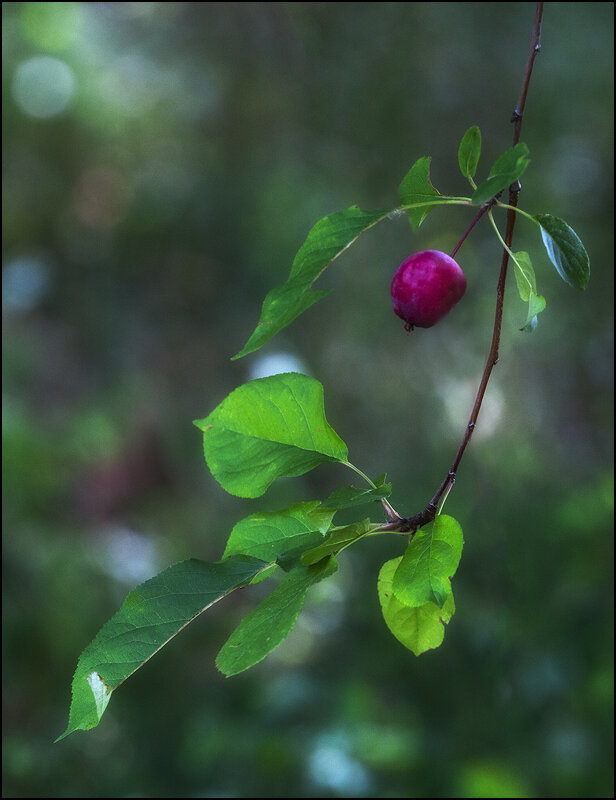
top-left (393, 514), bottom-right (463, 608)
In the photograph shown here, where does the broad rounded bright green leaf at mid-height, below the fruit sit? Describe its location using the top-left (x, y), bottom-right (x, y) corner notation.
top-left (194, 372), bottom-right (348, 497)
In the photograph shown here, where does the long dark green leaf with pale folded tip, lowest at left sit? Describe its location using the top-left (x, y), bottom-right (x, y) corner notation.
top-left (56, 556), bottom-right (267, 741)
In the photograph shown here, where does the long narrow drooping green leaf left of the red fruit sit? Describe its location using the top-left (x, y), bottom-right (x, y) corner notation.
top-left (233, 206), bottom-right (390, 359)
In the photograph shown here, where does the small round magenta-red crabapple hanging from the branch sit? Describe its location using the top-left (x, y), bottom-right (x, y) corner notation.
top-left (391, 250), bottom-right (466, 330)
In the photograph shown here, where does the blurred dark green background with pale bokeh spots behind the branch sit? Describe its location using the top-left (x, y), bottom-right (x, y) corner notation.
top-left (2, 2), bottom-right (614, 797)
